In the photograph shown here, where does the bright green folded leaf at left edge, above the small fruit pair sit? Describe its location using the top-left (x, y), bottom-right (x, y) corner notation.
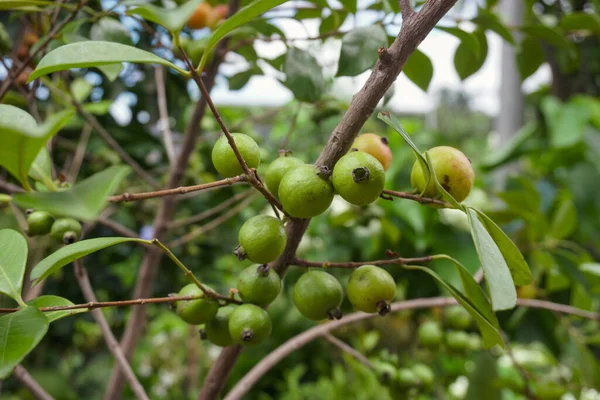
top-left (0, 104), bottom-right (74, 188)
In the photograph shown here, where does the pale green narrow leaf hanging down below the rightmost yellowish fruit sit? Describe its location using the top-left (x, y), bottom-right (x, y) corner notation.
top-left (467, 208), bottom-right (517, 311)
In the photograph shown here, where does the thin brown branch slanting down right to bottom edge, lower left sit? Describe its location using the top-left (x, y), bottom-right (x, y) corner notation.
top-left (75, 260), bottom-right (150, 400)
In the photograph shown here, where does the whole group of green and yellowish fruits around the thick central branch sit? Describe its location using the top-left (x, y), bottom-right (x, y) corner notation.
top-left (172, 133), bottom-right (473, 346)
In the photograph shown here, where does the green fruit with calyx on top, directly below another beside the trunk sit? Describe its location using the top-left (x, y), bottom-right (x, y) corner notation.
top-left (237, 265), bottom-right (281, 307)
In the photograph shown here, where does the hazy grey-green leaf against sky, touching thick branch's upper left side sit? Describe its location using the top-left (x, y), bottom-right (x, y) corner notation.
top-left (336, 25), bottom-right (388, 76)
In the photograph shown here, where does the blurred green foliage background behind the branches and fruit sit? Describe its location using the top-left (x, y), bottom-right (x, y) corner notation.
top-left (0, 0), bottom-right (600, 400)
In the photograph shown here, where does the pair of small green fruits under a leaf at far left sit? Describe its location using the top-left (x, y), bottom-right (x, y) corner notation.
top-left (25, 210), bottom-right (81, 244)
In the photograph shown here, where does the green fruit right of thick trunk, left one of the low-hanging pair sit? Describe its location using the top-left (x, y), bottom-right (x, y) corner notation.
top-left (294, 271), bottom-right (344, 321)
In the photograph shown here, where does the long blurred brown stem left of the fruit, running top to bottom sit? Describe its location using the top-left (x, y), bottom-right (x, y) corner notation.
top-left (104, 0), bottom-right (240, 400)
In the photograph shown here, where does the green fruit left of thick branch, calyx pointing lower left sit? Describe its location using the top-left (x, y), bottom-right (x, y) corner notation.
top-left (236, 215), bottom-right (286, 264)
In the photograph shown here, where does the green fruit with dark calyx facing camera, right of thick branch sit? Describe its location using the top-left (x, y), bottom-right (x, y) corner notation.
top-left (331, 151), bottom-right (385, 206)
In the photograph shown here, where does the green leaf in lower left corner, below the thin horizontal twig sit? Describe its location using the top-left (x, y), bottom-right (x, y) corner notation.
top-left (0, 307), bottom-right (49, 379)
